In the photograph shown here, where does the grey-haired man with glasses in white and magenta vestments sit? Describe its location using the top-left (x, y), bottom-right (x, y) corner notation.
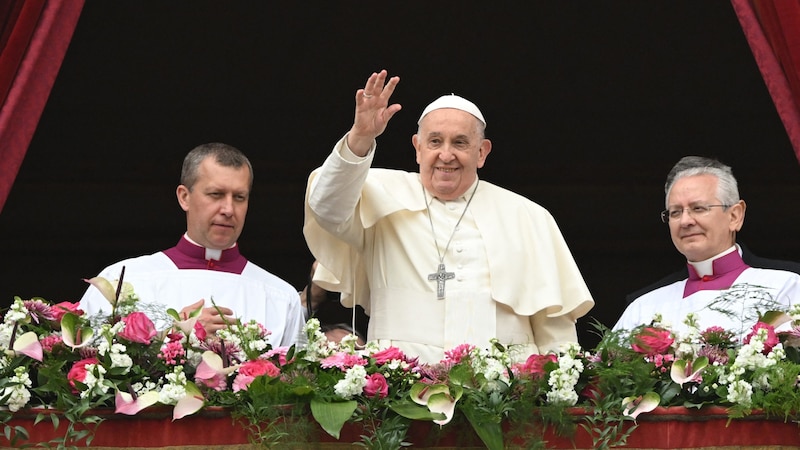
top-left (614, 156), bottom-right (800, 338)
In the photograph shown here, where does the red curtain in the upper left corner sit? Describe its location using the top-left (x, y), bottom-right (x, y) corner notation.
top-left (0, 0), bottom-right (84, 211)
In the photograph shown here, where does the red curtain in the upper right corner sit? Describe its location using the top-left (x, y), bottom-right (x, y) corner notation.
top-left (731, 0), bottom-right (800, 165)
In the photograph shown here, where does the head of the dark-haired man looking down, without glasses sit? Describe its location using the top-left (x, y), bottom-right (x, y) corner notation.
top-left (177, 156), bottom-right (250, 250)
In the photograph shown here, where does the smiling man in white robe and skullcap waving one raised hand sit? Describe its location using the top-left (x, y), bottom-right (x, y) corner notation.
top-left (304, 70), bottom-right (594, 362)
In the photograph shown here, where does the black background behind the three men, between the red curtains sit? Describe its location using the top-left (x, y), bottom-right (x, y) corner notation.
top-left (0, 0), bottom-right (800, 345)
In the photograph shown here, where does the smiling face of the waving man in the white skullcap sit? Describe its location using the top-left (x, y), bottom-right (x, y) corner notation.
top-left (411, 108), bottom-right (492, 200)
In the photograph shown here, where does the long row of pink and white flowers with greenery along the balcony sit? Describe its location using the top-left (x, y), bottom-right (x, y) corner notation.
top-left (0, 278), bottom-right (800, 449)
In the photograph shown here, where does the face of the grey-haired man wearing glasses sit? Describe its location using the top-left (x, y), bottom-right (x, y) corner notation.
top-left (667, 174), bottom-right (745, 262)
